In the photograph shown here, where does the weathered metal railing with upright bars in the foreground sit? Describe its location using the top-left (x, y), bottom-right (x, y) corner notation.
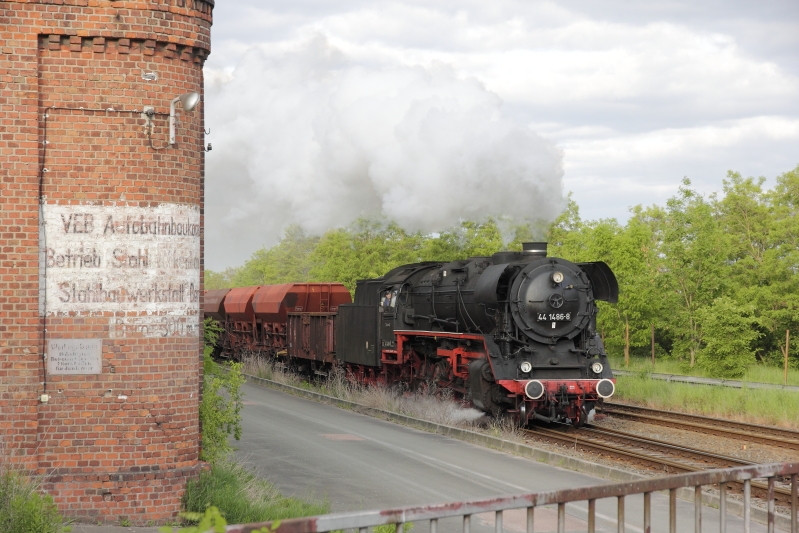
top-left (227, 463), bottom-right (799, 533)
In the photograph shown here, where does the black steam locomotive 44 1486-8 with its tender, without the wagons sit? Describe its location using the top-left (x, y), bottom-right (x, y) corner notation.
top-left (336, 243), bottom-right (618, 426)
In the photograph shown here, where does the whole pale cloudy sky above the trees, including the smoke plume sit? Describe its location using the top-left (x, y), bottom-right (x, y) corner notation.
top-left (204, 0), bottom-right (799, 270)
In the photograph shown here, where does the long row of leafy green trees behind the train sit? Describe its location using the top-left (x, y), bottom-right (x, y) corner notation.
top-left (205, 166), bottom-right (799, 377)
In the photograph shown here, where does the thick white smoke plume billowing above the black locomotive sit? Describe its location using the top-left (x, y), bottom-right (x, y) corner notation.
top-left (206, 36), bottom-right (563, 270)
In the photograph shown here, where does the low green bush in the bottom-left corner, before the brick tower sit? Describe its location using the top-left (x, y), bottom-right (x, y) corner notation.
top-left (0, 465), bottom-right (69, 533)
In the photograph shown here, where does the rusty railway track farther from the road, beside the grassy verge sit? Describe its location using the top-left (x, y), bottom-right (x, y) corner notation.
top-left (602, 402), bottom-right (799, 451)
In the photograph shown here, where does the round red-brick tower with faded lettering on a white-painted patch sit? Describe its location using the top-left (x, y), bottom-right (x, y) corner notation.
top-left (0, 0), bottom-right (213, 524)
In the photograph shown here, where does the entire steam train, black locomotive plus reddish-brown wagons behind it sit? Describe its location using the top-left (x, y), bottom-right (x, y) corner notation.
top-left (205, 243), bottom-right (619, 427)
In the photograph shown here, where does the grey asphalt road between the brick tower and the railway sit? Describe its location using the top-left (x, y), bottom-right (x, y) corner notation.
top-left (236, 384), bottom-right (765, 533)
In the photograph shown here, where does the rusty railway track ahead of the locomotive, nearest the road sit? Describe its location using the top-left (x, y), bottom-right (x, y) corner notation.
top-left (527, 425), bottom-right (791, 504)
